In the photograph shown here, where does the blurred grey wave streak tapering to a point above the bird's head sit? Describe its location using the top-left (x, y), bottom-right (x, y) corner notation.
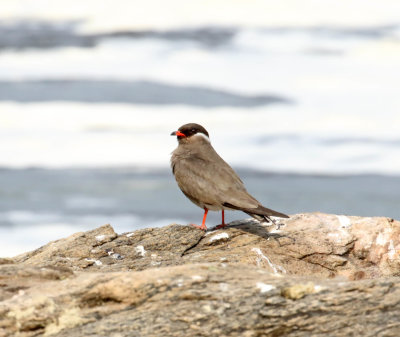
top-left (0, 79), bottom-right (290, 107)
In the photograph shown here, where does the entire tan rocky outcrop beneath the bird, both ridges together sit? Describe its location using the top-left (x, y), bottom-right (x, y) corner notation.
top-left (0, 213), bottom-right (400, 337)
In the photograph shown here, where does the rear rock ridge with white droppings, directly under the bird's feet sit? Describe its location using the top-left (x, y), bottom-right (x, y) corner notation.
top-left (14, 213), bottom-right (400, 279)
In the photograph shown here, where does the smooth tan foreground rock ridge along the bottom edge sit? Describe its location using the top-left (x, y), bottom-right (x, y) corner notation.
top-left (0, 263), bottom-right (400, 337)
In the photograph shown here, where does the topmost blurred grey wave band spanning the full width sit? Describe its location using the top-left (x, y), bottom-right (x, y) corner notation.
top-left (0, 20), bottom-right (400, 50)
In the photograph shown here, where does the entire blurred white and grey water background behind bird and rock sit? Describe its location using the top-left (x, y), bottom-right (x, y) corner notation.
top-left (0, 0), bottom-right (400, 256)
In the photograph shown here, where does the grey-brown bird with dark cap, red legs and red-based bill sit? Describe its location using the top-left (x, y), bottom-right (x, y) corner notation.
top-left (171, 123), bottom-right (289, 231)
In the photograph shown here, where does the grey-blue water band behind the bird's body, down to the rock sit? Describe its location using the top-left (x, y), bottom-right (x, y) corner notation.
top-left (0, 167), bottom-right (400, 256)
